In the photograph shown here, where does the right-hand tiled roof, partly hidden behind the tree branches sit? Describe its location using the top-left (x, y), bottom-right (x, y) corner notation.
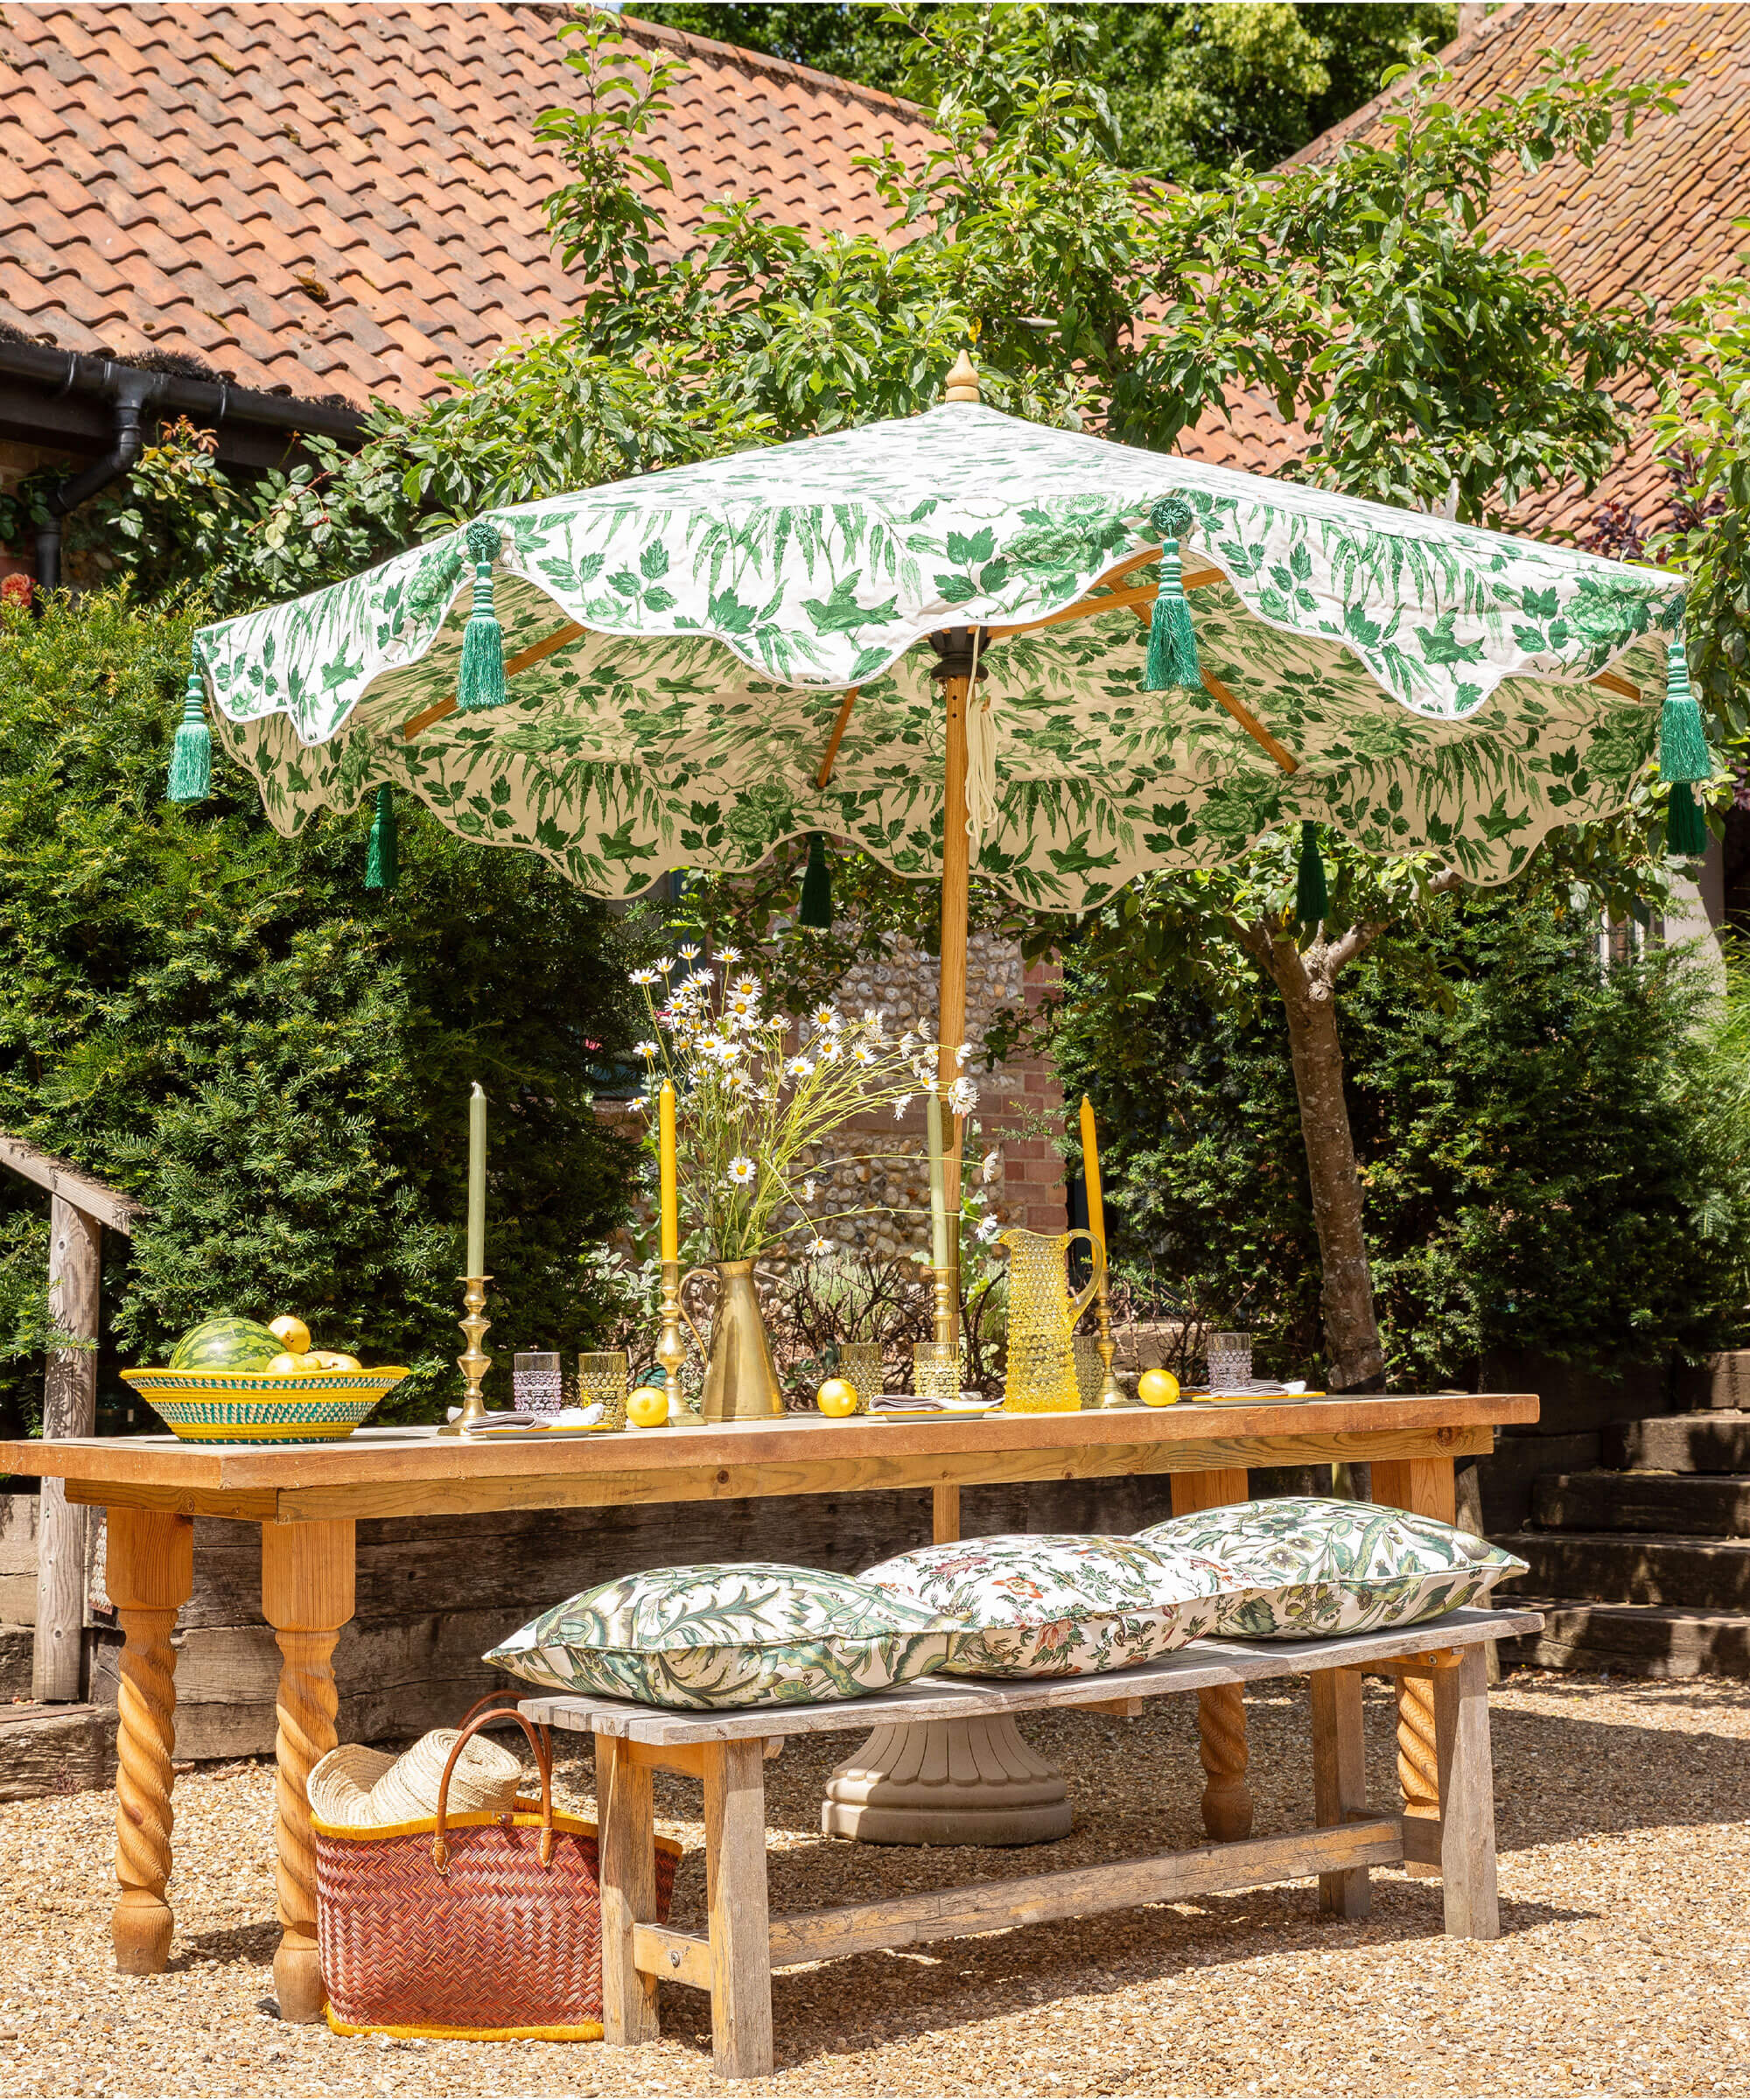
top-left (1180, 0), bottom-right (1750, 534)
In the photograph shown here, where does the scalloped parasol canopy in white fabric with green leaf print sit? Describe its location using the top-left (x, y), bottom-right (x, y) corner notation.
top-left (195, 403), bottom-right (1681, 912)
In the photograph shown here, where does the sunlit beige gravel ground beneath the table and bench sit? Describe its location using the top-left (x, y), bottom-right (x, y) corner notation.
top-left (0, 1674), bottom-right (1750, 2100)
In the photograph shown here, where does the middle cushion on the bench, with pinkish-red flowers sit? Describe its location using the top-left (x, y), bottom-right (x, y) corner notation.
top-left (861, 1533), bottom-right (1252, 1678)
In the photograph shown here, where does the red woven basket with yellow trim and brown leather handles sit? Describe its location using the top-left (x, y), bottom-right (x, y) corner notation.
top-left (311, 1707), bottom-right (681, 2041)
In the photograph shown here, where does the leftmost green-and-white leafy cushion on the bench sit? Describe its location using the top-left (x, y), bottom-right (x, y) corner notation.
top-left (486, 1560), bottom-right (956, 1707)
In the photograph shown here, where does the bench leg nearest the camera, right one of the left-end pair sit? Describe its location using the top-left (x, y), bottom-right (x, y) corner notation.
top-left (704, 1737), bottom-right (771, 2079)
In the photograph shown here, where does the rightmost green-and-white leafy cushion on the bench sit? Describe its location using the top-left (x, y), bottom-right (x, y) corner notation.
top-left (1137, 1495), bottom-right (1525, 1640)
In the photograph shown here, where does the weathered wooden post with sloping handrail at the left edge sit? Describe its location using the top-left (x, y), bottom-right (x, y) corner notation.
top-left (0, 1130), bottom-right (141, 1699)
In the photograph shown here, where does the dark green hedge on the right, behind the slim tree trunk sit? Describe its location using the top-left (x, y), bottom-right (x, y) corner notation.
top-left (1057, 886), bottom-right (1750, 1390)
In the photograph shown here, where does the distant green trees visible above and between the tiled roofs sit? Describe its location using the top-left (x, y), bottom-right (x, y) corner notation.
top-left (639, 0), bottom-right (1458, 178)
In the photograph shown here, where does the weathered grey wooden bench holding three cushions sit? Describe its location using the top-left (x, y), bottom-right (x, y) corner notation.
top-left (521, 1611), bottom-right (1542, 2079)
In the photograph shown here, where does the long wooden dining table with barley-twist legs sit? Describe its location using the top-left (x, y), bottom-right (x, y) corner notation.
top-left (0, 1392), bottom-right (1538, 2022)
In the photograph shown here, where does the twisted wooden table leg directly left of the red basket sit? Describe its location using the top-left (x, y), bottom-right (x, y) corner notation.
top-left (261, 1516), bottom-right (355, 2026)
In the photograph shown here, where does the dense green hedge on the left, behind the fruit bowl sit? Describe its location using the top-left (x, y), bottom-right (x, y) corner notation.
top-left (0, 592), bottom-right (633, 1422)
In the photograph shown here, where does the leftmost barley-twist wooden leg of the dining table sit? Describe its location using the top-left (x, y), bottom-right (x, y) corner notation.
top-left (103, 1508), bottom-right (195, 1976)
